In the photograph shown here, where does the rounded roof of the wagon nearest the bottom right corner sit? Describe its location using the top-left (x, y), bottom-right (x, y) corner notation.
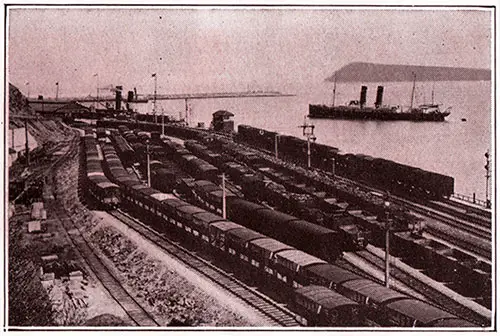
top-left (387, 298), bottom-right (455, 324)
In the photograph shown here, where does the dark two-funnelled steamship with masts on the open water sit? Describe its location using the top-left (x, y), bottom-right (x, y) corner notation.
top-left (309, 86), bottom-right (451, 121)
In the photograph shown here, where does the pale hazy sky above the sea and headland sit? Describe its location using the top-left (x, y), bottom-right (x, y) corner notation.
top-left (7, 7), bottom-right (493, 97)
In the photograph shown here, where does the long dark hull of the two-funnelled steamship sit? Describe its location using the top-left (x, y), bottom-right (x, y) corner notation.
top-left (309, 105), bottom-right (449, 121)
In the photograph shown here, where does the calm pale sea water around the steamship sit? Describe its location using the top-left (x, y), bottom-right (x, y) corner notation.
top-left (130, 81), bottom-right (492, 199)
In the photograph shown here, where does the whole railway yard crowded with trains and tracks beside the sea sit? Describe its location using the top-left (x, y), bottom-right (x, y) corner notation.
top-left (9, 111), bottom-right (495, 330)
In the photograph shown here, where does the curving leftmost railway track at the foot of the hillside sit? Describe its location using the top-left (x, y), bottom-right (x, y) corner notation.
top-left (44, 131), bottom-right (160, 327)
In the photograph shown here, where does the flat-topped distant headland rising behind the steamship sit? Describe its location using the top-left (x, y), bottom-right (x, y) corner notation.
top-left (325, 62), bottom-right (491, 82)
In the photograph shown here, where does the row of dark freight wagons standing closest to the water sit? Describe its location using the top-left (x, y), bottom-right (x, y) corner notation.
top-left (238, 125), bottom-right (454, 199)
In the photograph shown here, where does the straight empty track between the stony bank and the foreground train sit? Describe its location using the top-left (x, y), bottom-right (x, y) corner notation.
top-left (109, 210), bottom-right (300, 327)
